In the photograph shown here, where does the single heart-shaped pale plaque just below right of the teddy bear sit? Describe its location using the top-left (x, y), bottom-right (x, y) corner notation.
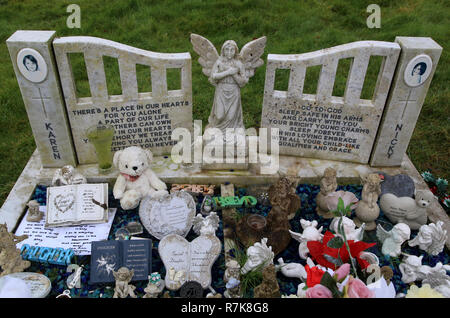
top-left (139, 191), bottom-right (195, 240)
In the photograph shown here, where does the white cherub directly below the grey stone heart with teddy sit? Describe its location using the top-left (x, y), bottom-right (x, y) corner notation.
top-left (377, 223), bottom-right (411, 257)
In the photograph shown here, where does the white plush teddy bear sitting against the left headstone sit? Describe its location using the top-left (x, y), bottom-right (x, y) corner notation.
top-left (113, 146), bottom-right (168, 210)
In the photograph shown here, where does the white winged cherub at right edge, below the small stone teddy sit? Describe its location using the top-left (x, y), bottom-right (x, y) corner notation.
top-left (408, 221), bottom-right (447, 255)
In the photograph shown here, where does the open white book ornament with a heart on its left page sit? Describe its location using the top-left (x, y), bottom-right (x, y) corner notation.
top-left (45, 183), bottom-right (108, 227)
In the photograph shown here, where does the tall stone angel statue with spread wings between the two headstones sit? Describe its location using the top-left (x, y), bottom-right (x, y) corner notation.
top-left (191, 34), bottom-right (266, 136)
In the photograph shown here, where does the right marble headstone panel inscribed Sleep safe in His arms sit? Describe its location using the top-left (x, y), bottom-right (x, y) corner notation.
top-left (261, 41), bottom-right (400, 163)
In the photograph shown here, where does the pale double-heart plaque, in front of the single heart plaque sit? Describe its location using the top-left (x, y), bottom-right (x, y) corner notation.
top-left (158, 234), bottom-right (222, 290)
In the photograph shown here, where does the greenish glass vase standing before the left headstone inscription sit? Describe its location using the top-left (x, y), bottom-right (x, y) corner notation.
top-left (86, 124), bottom-right (114, 174)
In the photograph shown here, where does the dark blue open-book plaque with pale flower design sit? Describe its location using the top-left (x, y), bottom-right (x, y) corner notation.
top-left (89, 239), bottom-right (152, 284)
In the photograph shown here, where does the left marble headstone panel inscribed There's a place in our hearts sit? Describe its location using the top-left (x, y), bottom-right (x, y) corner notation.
top-left (53, 36), bottom-right (192, 164)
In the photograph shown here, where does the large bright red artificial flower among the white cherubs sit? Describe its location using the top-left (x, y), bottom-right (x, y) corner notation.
top-left (307, 231), bottom-right (376, 270)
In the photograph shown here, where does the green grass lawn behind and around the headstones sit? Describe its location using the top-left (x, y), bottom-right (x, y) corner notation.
top-left (0, 0), bottom-right (450, 204)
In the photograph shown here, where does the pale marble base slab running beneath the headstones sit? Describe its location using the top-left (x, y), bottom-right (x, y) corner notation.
top-left (0, 150), bottom-right (450, 247)
